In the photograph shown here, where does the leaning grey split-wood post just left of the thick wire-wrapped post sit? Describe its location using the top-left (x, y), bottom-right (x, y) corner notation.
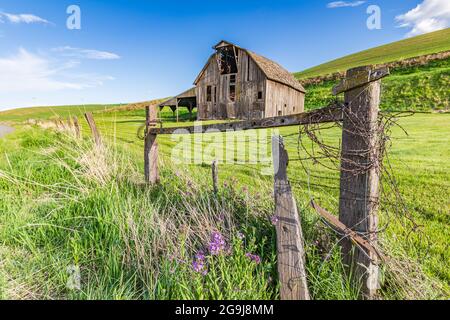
top-left (272, 136), bottom-right (310, 300)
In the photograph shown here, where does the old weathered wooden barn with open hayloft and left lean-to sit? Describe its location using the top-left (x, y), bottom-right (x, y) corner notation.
top-left (160, 41), bottom-right (305, 120)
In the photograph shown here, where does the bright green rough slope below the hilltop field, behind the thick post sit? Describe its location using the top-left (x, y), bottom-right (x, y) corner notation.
top-left (305, 58), bottom-right (450, 112)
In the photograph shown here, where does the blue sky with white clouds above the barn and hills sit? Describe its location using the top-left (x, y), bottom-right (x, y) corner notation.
top-left (0, 0), bottom-right (450, 110)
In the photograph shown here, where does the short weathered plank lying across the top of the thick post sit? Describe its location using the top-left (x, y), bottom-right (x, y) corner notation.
top-left (333, 67), bottom-right (389, 95)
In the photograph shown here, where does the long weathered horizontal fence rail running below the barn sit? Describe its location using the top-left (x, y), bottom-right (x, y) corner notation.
top-left (150, 107), bottom-right (342, 134)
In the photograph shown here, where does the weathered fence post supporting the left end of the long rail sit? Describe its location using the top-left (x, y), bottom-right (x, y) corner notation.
top-left (144, 106), bottom-right (159, 184)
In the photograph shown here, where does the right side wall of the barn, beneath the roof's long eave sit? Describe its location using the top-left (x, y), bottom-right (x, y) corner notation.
top-left (265, 80), bottom-right (305, 118)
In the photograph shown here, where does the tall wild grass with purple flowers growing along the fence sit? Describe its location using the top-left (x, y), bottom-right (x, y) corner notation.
top-left (0, 128), bottom-right (446, 299)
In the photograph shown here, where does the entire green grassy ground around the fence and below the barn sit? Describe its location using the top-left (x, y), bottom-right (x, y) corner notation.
top-left (0, 110), bottom-right (450, 299)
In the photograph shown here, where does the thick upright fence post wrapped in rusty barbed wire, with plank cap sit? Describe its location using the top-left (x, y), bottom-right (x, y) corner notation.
top-left (333, 66), bottom-right (389, 299)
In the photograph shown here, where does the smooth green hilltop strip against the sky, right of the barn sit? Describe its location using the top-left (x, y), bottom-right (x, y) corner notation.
top-left (295, 28), bottom-right (450, 79)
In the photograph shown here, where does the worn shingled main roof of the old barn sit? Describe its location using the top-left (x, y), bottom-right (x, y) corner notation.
top-left (194, 40), bottom-right (306, 93)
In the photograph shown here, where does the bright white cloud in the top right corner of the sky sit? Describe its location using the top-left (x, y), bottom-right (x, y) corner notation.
top-left (395, 0), bottom-right (450, 37)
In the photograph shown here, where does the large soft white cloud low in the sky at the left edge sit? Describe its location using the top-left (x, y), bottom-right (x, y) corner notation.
top-left (0, 48), bottom-right (112, 92)
